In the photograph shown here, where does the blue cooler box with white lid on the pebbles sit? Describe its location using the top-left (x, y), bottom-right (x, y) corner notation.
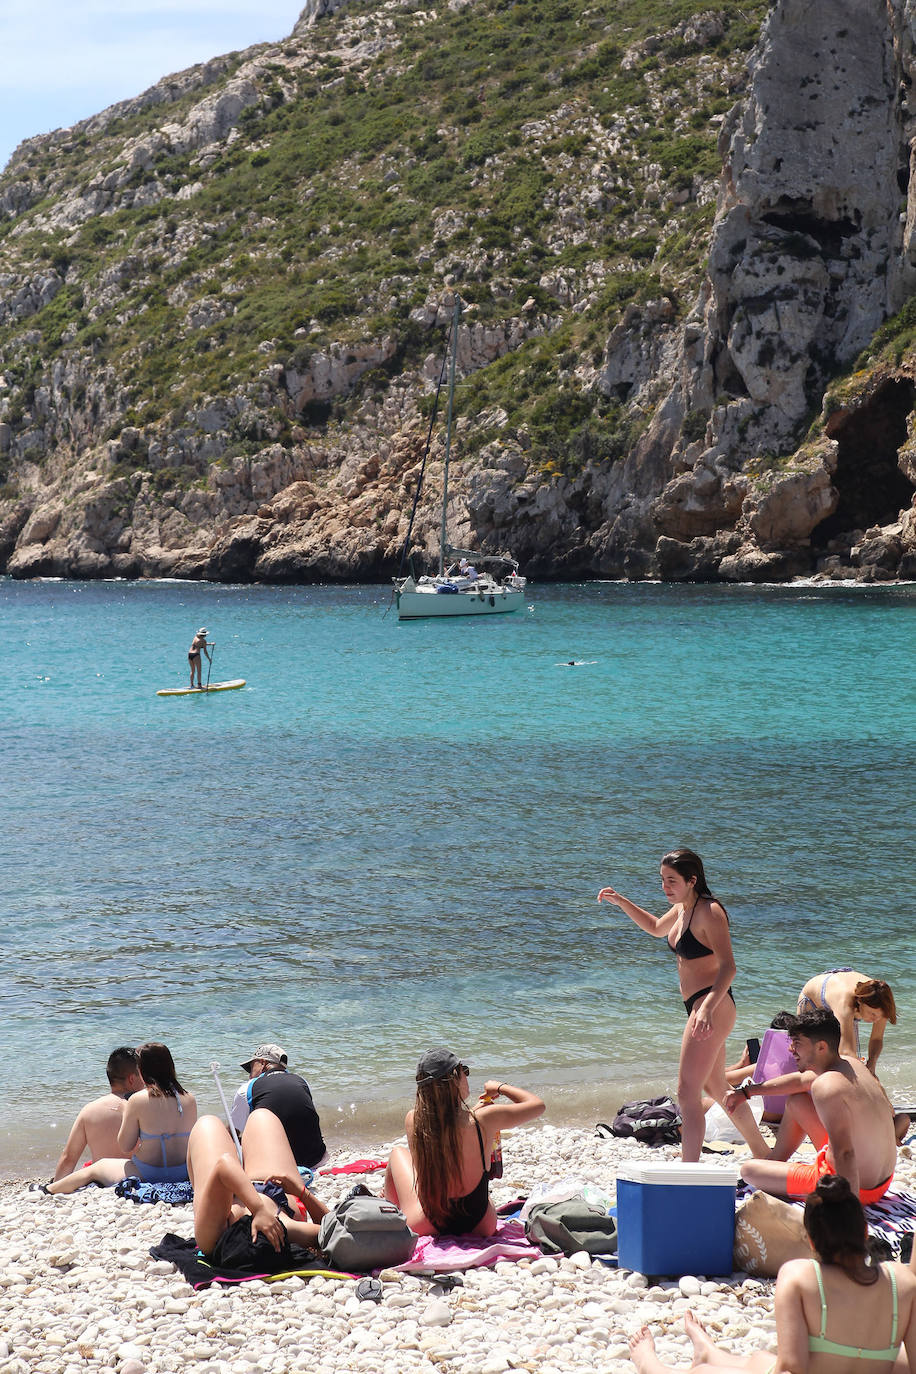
top-left (617, 1161), bottom-right (737, 1278)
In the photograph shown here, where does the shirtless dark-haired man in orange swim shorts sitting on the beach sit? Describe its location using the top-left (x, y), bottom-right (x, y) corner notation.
top-left (725, 1011), bottom-right (897, 1202)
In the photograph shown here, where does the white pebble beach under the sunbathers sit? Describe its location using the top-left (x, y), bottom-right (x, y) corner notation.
top-left (8, 1124), bottom-right (916, 1374)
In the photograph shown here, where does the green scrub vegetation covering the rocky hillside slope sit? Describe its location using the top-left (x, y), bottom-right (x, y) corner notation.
top-left (0, 0), bottom-right (768, 480)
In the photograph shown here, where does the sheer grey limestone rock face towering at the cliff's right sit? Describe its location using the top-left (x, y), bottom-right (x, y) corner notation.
top-left (620, 0), bottom-right (916, 577)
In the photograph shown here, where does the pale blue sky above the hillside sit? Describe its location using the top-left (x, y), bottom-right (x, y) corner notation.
top-left (0, 0), bottom-right (305, 168)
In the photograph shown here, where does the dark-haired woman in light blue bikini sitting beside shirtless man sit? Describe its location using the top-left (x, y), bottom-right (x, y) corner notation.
top-left (47, 1041), bottom-right (198, 1193)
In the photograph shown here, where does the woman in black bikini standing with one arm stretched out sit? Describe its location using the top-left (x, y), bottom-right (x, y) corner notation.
top-left (597, 849), bottom-right (769, 1164)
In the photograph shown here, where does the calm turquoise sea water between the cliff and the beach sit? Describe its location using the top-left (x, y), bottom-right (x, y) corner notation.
top-left (0, 580), bottom-right (916, 1173)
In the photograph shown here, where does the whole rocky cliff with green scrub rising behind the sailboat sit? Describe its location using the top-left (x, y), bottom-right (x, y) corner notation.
top-left (0, 0), bottom-right (916, 581)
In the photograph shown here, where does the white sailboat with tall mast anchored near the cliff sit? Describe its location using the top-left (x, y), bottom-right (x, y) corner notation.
top-left (394, 295), bottom-right (526, 620)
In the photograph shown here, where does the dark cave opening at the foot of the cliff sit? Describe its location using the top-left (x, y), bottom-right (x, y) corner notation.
top-left (814, 378), bottom-right (916, 547)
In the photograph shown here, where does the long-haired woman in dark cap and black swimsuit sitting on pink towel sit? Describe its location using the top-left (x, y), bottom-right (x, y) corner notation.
top-left (385, 1050), bottom-right (544, 1235)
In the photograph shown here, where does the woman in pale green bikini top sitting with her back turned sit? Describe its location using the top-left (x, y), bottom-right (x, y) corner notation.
top-left (630, 1176), bottom-right (916, 1374)
